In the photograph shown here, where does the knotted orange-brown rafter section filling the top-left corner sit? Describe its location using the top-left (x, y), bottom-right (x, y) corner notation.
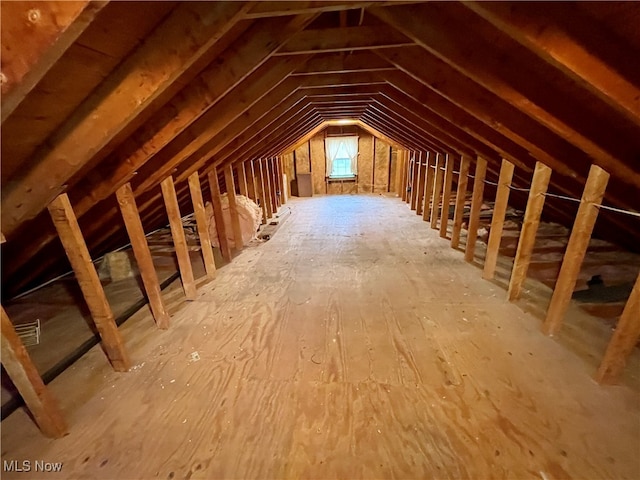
top-left (0, 0), bottom-right (108, 122)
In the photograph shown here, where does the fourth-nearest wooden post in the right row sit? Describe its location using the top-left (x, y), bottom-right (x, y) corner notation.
top-left (482, 158), bottom-right (515, 280)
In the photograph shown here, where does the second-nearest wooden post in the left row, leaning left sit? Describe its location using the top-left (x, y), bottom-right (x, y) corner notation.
top-left (48, 193), bottom-right (130, 372)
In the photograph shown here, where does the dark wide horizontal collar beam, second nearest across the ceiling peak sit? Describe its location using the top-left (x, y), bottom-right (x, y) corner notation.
top-left (277, 25), bottom-right (413, 55)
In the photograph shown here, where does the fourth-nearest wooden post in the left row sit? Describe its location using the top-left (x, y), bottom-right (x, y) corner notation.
top-left (160, 176), bottom-right (198, 300)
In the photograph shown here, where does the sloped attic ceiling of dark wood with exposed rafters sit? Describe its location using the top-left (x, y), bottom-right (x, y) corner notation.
top-left (0, 1), bottom-right (640, 293)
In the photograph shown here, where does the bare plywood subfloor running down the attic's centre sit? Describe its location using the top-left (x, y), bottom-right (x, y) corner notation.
top-left (2, 195), bottom-right (640, 480)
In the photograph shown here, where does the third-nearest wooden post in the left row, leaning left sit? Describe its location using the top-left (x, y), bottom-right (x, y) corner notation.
top-left (116, 183), bottom-right (169, 330)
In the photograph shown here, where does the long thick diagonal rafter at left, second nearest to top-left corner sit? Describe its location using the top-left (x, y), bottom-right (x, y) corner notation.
top-left (1, 2), bottom-right (252, 235)
